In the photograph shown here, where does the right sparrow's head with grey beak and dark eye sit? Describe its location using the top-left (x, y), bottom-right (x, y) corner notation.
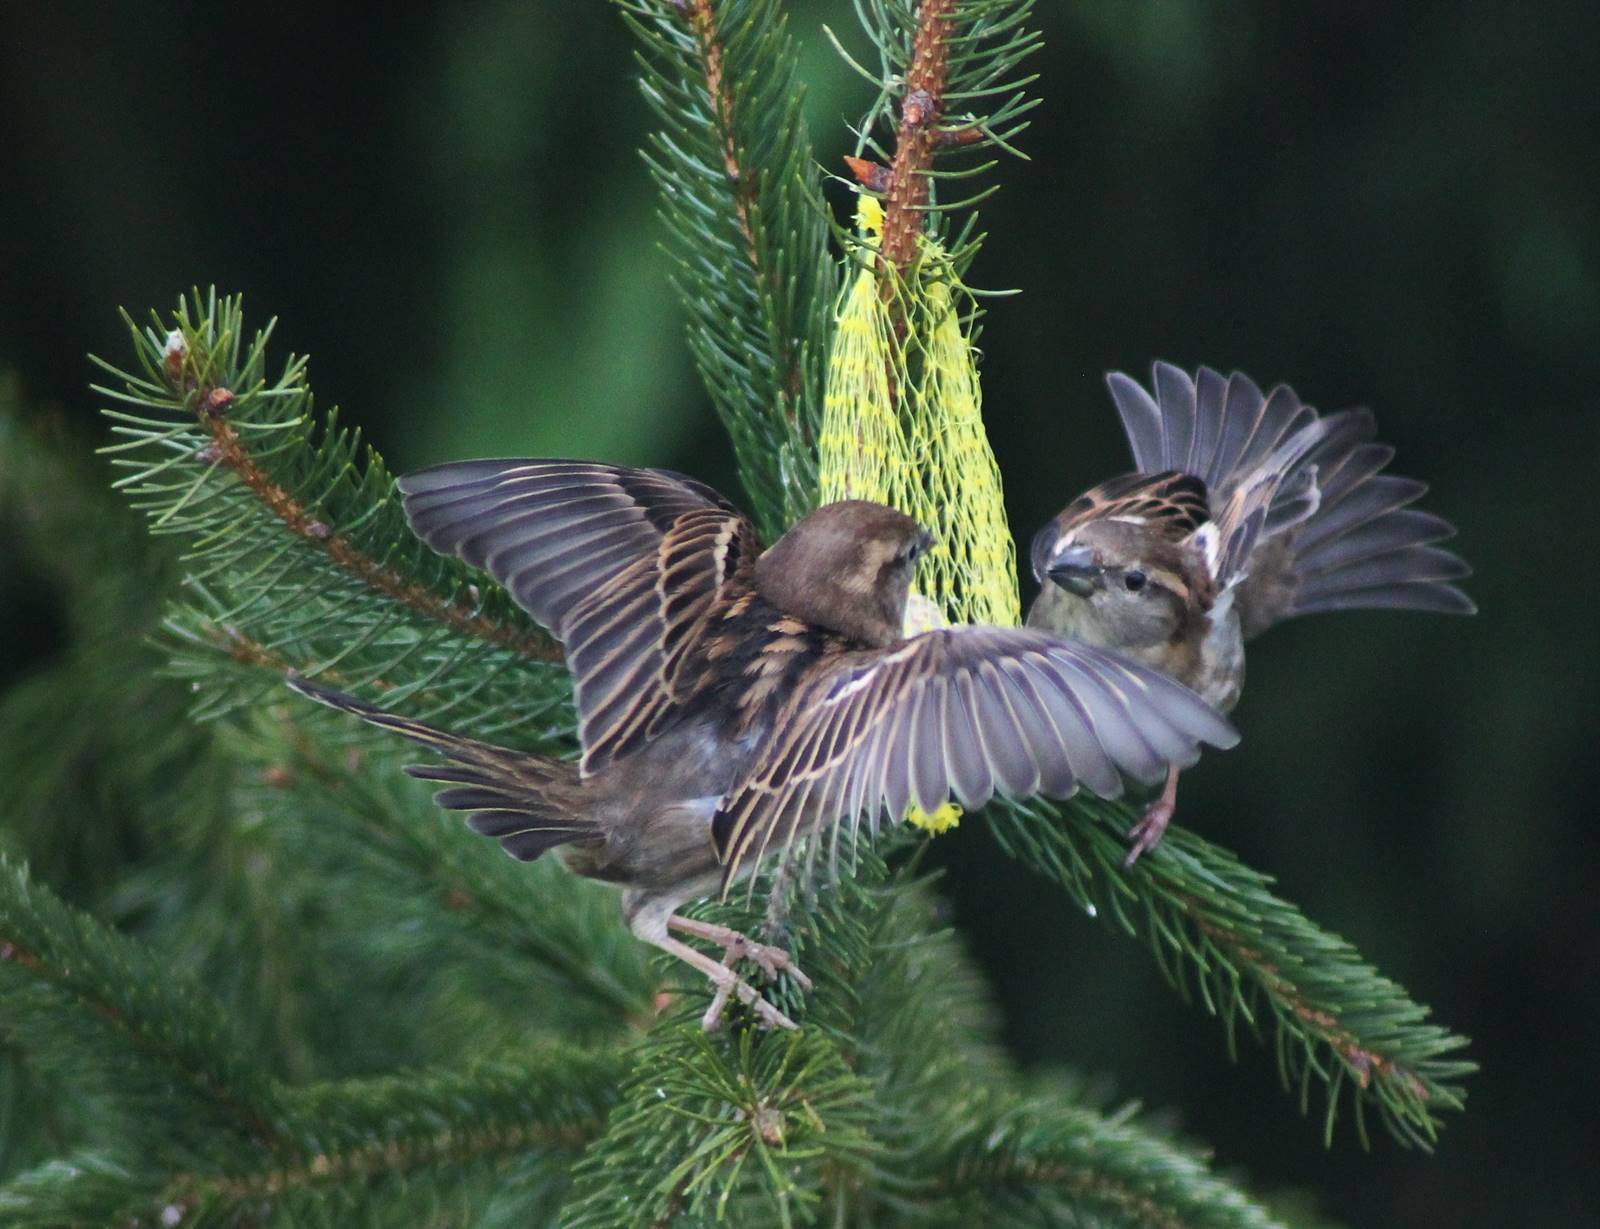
top-left (1029, 517), bottom-right (1203, 648)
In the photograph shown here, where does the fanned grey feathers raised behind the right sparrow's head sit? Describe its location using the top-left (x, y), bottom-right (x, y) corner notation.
top-left (1106, 363), bottom-right (1475, 637)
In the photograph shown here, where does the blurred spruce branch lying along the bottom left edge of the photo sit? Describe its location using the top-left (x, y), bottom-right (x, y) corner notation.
top-left (0, 1045), bottom-right (626, 1229)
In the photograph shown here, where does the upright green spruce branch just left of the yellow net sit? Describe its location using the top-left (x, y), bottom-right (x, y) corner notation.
top-left (619, 0), bottom-right (834, 538)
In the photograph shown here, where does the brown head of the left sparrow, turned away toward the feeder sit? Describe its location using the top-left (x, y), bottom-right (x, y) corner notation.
top-left (755, 499), bottom-right (933, 648)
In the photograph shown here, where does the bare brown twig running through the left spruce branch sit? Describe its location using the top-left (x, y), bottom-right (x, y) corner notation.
top-left (192, 387), bottom-right (562, 661)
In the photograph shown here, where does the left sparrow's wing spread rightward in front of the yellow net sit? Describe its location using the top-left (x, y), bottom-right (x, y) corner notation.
top-left (712, 627), bottom-right (1238, 883)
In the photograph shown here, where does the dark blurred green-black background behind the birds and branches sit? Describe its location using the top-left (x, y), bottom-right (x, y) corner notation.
top-left (0, 0), bottom-right (1600, 1226)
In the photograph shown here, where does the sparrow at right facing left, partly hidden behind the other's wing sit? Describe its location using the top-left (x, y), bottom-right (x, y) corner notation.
top-left (1027, 363), bottom-right (1475, 866)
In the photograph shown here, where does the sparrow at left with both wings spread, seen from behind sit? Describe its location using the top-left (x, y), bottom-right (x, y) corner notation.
top-left (290, 461), bottom-right (1237, 1029)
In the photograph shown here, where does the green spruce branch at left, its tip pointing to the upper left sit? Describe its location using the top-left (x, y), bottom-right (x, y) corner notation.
top-left (96, 293), bottom-right (570, 739)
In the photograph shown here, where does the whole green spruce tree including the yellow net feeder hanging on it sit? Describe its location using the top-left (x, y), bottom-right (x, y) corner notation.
top-left (0, 0), bottom-right (1470, 1229)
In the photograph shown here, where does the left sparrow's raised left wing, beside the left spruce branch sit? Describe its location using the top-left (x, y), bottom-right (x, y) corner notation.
top-left (400, 461), bottom-right (760, 775)
